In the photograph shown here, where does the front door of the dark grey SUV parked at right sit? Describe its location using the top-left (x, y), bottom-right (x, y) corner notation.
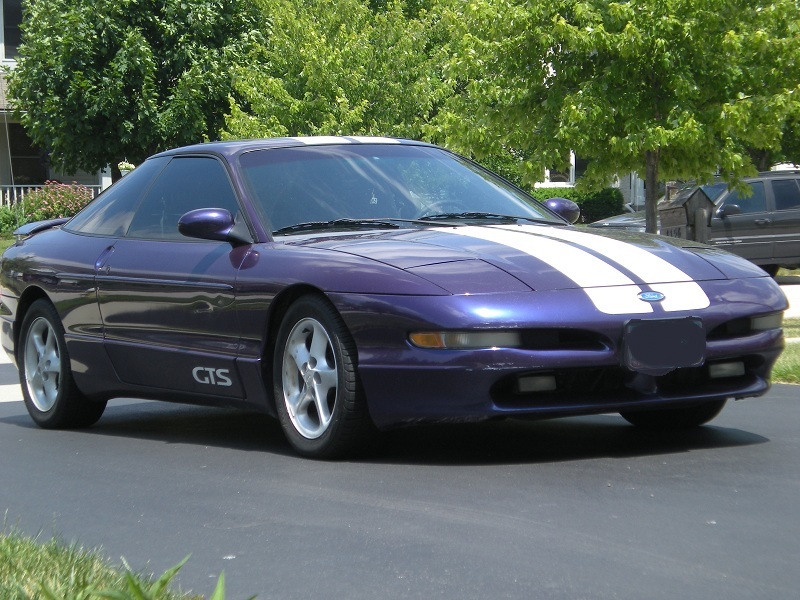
top-left (709, 181), bottom-right (772, 263)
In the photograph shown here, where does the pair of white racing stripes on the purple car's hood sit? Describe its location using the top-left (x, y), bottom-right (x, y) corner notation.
top-left (438, 226), bottom-right (710, 315)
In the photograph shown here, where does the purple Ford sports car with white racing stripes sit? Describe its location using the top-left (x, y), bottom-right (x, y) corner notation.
top-left (0, 138), bottom-right (787, 457)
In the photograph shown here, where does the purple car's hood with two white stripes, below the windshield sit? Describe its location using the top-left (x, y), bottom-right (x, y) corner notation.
top-left (290, 225), bottom-right (765, 310)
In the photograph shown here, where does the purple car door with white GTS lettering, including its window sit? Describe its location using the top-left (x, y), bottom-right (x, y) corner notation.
top-left (97, 156), bottom-right (253, 398)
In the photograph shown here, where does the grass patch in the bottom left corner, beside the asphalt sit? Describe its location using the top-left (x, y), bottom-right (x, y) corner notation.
top-left (0, 531), bottom-right (225, 600)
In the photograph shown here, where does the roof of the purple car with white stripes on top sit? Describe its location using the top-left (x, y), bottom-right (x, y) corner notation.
top-left (155, 136), bottom-right (435, 157)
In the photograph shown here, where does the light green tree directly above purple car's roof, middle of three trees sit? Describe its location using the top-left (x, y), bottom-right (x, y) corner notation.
top-left (225, 0), bottom-right (447, 138)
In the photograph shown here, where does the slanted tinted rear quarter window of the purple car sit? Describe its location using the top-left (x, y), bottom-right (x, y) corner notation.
top-left (64, 157), bottom-right (169, 237)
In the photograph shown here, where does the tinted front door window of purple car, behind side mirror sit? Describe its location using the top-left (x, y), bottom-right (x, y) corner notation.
top-left (127, 157), bottom-right (239, 241)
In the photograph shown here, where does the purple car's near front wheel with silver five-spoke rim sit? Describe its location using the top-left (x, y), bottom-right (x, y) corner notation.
top-left (272, 296), bottom-right (374, 459)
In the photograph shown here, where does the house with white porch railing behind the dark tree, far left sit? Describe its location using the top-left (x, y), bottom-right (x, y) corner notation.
top-left (0, 0), bottom-right (111, 205)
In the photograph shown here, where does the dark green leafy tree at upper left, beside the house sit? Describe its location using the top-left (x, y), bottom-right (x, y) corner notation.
top-left (9, 0), bottom-right (258, 177)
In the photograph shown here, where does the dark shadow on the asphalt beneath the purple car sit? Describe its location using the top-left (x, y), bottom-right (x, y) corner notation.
top-left (0, 400), bottom-right (769, 465)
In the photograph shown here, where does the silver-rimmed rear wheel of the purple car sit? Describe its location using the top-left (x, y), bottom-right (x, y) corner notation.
top-left (17, 300), bottom-right (106, 429)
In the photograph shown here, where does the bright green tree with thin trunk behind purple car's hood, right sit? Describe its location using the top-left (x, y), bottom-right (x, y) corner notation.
top-left (437, 0), bottom-right (800, 231)
